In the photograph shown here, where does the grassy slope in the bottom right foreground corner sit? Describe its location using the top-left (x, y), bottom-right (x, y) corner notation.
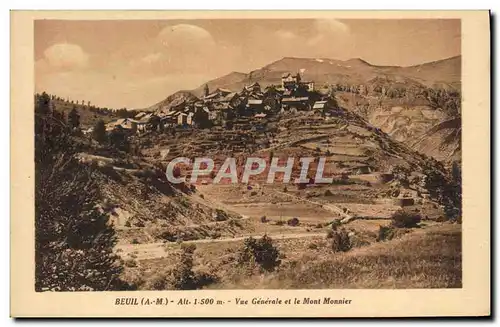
top-left (216, 224), bottom-right (462, 289)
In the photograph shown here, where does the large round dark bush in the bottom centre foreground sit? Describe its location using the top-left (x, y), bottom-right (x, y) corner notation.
top-left (237, 235), bottom-right (281, 271)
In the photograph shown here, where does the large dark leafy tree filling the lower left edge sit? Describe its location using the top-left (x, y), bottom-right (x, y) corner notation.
top-left (35, 103), bottom-right (127, 291)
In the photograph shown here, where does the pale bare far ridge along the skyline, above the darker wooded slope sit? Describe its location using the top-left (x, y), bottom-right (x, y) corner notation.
top-left (189, 56), bottom-right (461, 94)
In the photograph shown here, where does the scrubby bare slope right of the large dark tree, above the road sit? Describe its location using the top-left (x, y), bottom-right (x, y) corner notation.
top-left (77, 147), bottom-right (245, 244)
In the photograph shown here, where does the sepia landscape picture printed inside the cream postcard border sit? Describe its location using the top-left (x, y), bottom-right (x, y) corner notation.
top-left (9, 9), bottom-right (489, 318)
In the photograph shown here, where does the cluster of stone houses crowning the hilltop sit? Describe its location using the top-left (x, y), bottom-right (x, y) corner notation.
top-left (98, 73), bottom-right (342, 134)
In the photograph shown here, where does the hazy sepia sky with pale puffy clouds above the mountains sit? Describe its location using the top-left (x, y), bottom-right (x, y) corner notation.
top-left (34, 19), bottom-right (461, 109)
